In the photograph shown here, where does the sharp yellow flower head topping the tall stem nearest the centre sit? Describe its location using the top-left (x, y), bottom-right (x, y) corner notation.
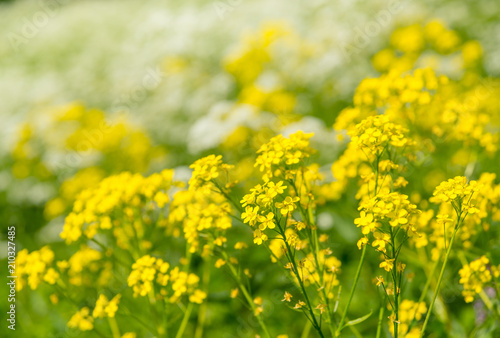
top-left (255, 131), bottom-right (313, 181)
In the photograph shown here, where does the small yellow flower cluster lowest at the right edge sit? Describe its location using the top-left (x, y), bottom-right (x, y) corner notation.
top-left (459, 256), bottom-right (500, 303)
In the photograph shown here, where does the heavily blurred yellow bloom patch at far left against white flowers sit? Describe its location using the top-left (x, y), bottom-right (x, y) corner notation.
top-left (11, 103), bottom-right (165, 219)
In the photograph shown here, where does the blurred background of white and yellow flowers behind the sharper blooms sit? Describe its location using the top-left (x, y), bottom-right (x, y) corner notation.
top-left (0, 0), bottom-right (500, 336)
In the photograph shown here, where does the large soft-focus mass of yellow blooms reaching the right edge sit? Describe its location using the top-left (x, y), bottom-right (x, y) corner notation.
top-left (332, 60), bottom-right (500, 199)
